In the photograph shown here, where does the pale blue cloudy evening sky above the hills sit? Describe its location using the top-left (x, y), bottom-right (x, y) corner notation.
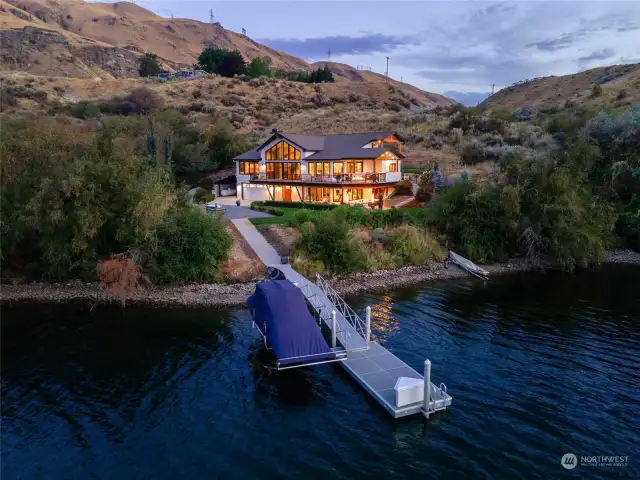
top-left (136, 0), bottom-right (640, 105)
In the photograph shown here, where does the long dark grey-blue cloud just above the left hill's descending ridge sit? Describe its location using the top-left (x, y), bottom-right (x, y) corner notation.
top-left (260, 33), bottom-right (419, 58)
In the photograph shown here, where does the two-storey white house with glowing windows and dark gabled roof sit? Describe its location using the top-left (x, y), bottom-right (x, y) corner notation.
top-left (234, 129), bottom-right (403, 203)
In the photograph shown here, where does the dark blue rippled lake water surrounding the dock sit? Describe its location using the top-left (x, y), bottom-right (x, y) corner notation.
top-left (2, 268), bottom-right (640, 480)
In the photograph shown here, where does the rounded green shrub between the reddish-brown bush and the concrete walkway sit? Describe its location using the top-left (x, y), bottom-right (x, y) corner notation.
top-left (152, 206), bottom-right (232, 283)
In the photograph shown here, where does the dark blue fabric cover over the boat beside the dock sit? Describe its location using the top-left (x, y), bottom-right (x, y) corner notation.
top-left (247, 280), bottom-right (336, 366)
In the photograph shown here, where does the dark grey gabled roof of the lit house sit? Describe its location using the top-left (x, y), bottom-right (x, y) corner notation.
top-left (234, 131), bottom-right (403, 160)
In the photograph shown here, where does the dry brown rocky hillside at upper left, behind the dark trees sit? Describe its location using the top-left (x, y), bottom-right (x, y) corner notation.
top-left (0, 0), bottom-right (452, 108)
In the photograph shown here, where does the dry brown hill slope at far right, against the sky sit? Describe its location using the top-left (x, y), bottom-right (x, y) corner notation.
top-left (481, 63), bottom-right (640, 110)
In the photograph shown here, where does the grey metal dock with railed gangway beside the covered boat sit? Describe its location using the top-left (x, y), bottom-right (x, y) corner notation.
top-left (268, 264), bottom-right (452, 418)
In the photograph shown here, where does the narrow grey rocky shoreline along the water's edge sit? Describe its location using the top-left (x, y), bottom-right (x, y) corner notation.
top-left (0, 250), bottom-right (640, 308)
